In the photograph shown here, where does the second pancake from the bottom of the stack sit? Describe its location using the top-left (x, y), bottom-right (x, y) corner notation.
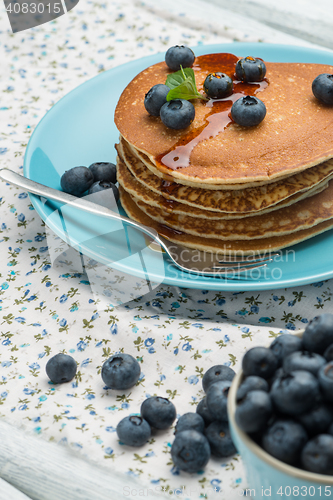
top-left (128, 181), bottom-right (333, 240)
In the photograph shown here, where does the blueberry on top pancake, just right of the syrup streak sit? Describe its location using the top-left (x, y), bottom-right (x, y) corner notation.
top-left (231, 95), bottom-right (266, 127)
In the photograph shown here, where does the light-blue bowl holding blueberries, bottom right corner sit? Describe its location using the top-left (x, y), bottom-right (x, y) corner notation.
top-left (228, 333), bottom-right (333, 500)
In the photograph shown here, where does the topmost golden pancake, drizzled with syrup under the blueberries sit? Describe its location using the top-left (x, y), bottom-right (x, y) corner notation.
top-left (115, 54), bottom-right (333, 186)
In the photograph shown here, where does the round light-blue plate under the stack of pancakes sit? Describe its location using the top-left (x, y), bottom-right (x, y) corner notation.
top-left (24, 43), bottom-right (333, 291)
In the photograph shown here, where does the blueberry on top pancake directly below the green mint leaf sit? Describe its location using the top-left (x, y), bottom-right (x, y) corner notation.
top-left (160, 99), bottom-right (195, 130)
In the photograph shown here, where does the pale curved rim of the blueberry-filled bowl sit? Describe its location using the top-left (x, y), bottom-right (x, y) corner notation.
top-left (228, 330), bottom-right (333, 486)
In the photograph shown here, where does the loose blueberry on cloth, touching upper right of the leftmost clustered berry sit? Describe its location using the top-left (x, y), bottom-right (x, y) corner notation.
top-left (141, 396), bottom-right (176, 429)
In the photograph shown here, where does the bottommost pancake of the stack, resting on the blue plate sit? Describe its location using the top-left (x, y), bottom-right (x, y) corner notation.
top-left (119, 187), bottom-right (333, 256)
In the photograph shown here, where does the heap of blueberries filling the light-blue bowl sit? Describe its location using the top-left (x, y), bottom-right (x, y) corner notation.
top-left (229, 314), bottom-right (333, 475)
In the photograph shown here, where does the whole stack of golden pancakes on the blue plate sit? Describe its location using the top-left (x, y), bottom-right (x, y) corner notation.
top-left (115, 54), bottom-right (333, 255)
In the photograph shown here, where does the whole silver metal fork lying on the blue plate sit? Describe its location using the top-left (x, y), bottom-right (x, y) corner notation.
top-left (0, 168), bottom-right (279, 277)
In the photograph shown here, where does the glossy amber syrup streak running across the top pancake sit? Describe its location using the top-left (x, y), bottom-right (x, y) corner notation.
top-left (155, 54), bottom-right (268, 170)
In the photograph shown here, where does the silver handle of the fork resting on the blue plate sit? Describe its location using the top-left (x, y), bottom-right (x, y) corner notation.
top-left (0, 168), bottom-right (163, 246)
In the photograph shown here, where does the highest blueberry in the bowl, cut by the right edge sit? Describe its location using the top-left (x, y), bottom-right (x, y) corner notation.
top-left (303, 313), bottom-right (333, 354)
